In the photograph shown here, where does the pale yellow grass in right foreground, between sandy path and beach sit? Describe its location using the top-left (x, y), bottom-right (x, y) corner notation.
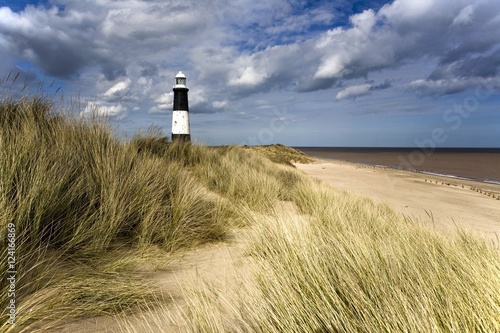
top-left (184, 179), bottom-right (500, 332)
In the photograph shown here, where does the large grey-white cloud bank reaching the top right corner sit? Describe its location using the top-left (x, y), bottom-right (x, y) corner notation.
top-left (304, 0), bottom-right (500, 91)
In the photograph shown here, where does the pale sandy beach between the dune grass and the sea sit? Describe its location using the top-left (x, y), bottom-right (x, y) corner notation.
top-left (295, 159), bottom-right (500, 245)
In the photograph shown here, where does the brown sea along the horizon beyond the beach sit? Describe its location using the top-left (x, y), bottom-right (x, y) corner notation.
top-left (293, 147), bottom-right (500, 185)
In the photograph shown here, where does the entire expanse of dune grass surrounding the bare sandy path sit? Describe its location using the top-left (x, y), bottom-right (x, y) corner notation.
top-left (0, 92), bottom-right (500, 332)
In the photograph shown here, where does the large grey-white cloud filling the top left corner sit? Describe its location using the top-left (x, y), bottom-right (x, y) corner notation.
top-left (0, 0), bottom-right (211, 80)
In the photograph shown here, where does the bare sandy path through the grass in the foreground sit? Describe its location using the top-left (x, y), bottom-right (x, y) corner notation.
top-left (43, 229), bottom-right (255, 333)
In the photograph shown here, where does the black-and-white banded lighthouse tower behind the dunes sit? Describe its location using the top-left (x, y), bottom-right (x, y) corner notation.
top-left (172, 72), bottom-right (191, 141)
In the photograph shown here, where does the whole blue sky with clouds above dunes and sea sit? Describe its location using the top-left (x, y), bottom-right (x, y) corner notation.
top-left (0, 0), bottom-right (500, 149)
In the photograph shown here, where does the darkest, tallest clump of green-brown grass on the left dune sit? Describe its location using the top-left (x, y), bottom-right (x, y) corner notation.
top-left (0, 95), bottom-right (230, 249)
